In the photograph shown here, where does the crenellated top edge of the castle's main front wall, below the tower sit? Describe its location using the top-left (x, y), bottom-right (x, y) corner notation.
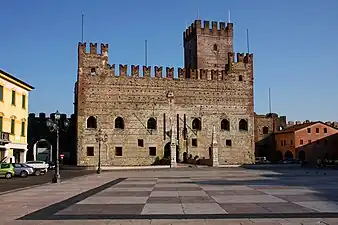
top-left (79, 43), bottom-right (253, 81)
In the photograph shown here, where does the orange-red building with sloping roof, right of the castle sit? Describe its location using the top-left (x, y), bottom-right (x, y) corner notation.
top-left (275, 122), bottom-right (338, 163)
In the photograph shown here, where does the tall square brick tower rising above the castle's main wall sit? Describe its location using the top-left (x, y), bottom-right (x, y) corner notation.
top-left (183, 20), bottom-right (233, 70)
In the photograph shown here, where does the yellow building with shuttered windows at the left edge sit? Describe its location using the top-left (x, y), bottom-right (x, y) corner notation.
top-left (0, 69), bottom-right (34, 162)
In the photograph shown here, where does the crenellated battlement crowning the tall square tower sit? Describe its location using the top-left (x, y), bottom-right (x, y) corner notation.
top-left (183, 20), bottom-right (233, 43)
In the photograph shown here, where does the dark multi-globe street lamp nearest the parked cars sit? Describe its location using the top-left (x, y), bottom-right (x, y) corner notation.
top-left (46, 110), bottom-right (69, 183)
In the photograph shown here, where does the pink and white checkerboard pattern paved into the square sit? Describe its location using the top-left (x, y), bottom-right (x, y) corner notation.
top-left (54, 177), bottom-right (338, 217)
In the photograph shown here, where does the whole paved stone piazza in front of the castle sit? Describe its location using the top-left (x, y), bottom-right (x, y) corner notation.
top-left (0, 168), bottom-right (338, 225)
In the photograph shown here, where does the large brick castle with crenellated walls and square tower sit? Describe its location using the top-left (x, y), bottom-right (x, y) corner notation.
top-left (74, 20), bottom-right (255, 166)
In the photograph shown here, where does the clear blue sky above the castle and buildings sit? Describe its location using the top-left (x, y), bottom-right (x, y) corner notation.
top-left (0, 0), bottom-right (338, 121)
